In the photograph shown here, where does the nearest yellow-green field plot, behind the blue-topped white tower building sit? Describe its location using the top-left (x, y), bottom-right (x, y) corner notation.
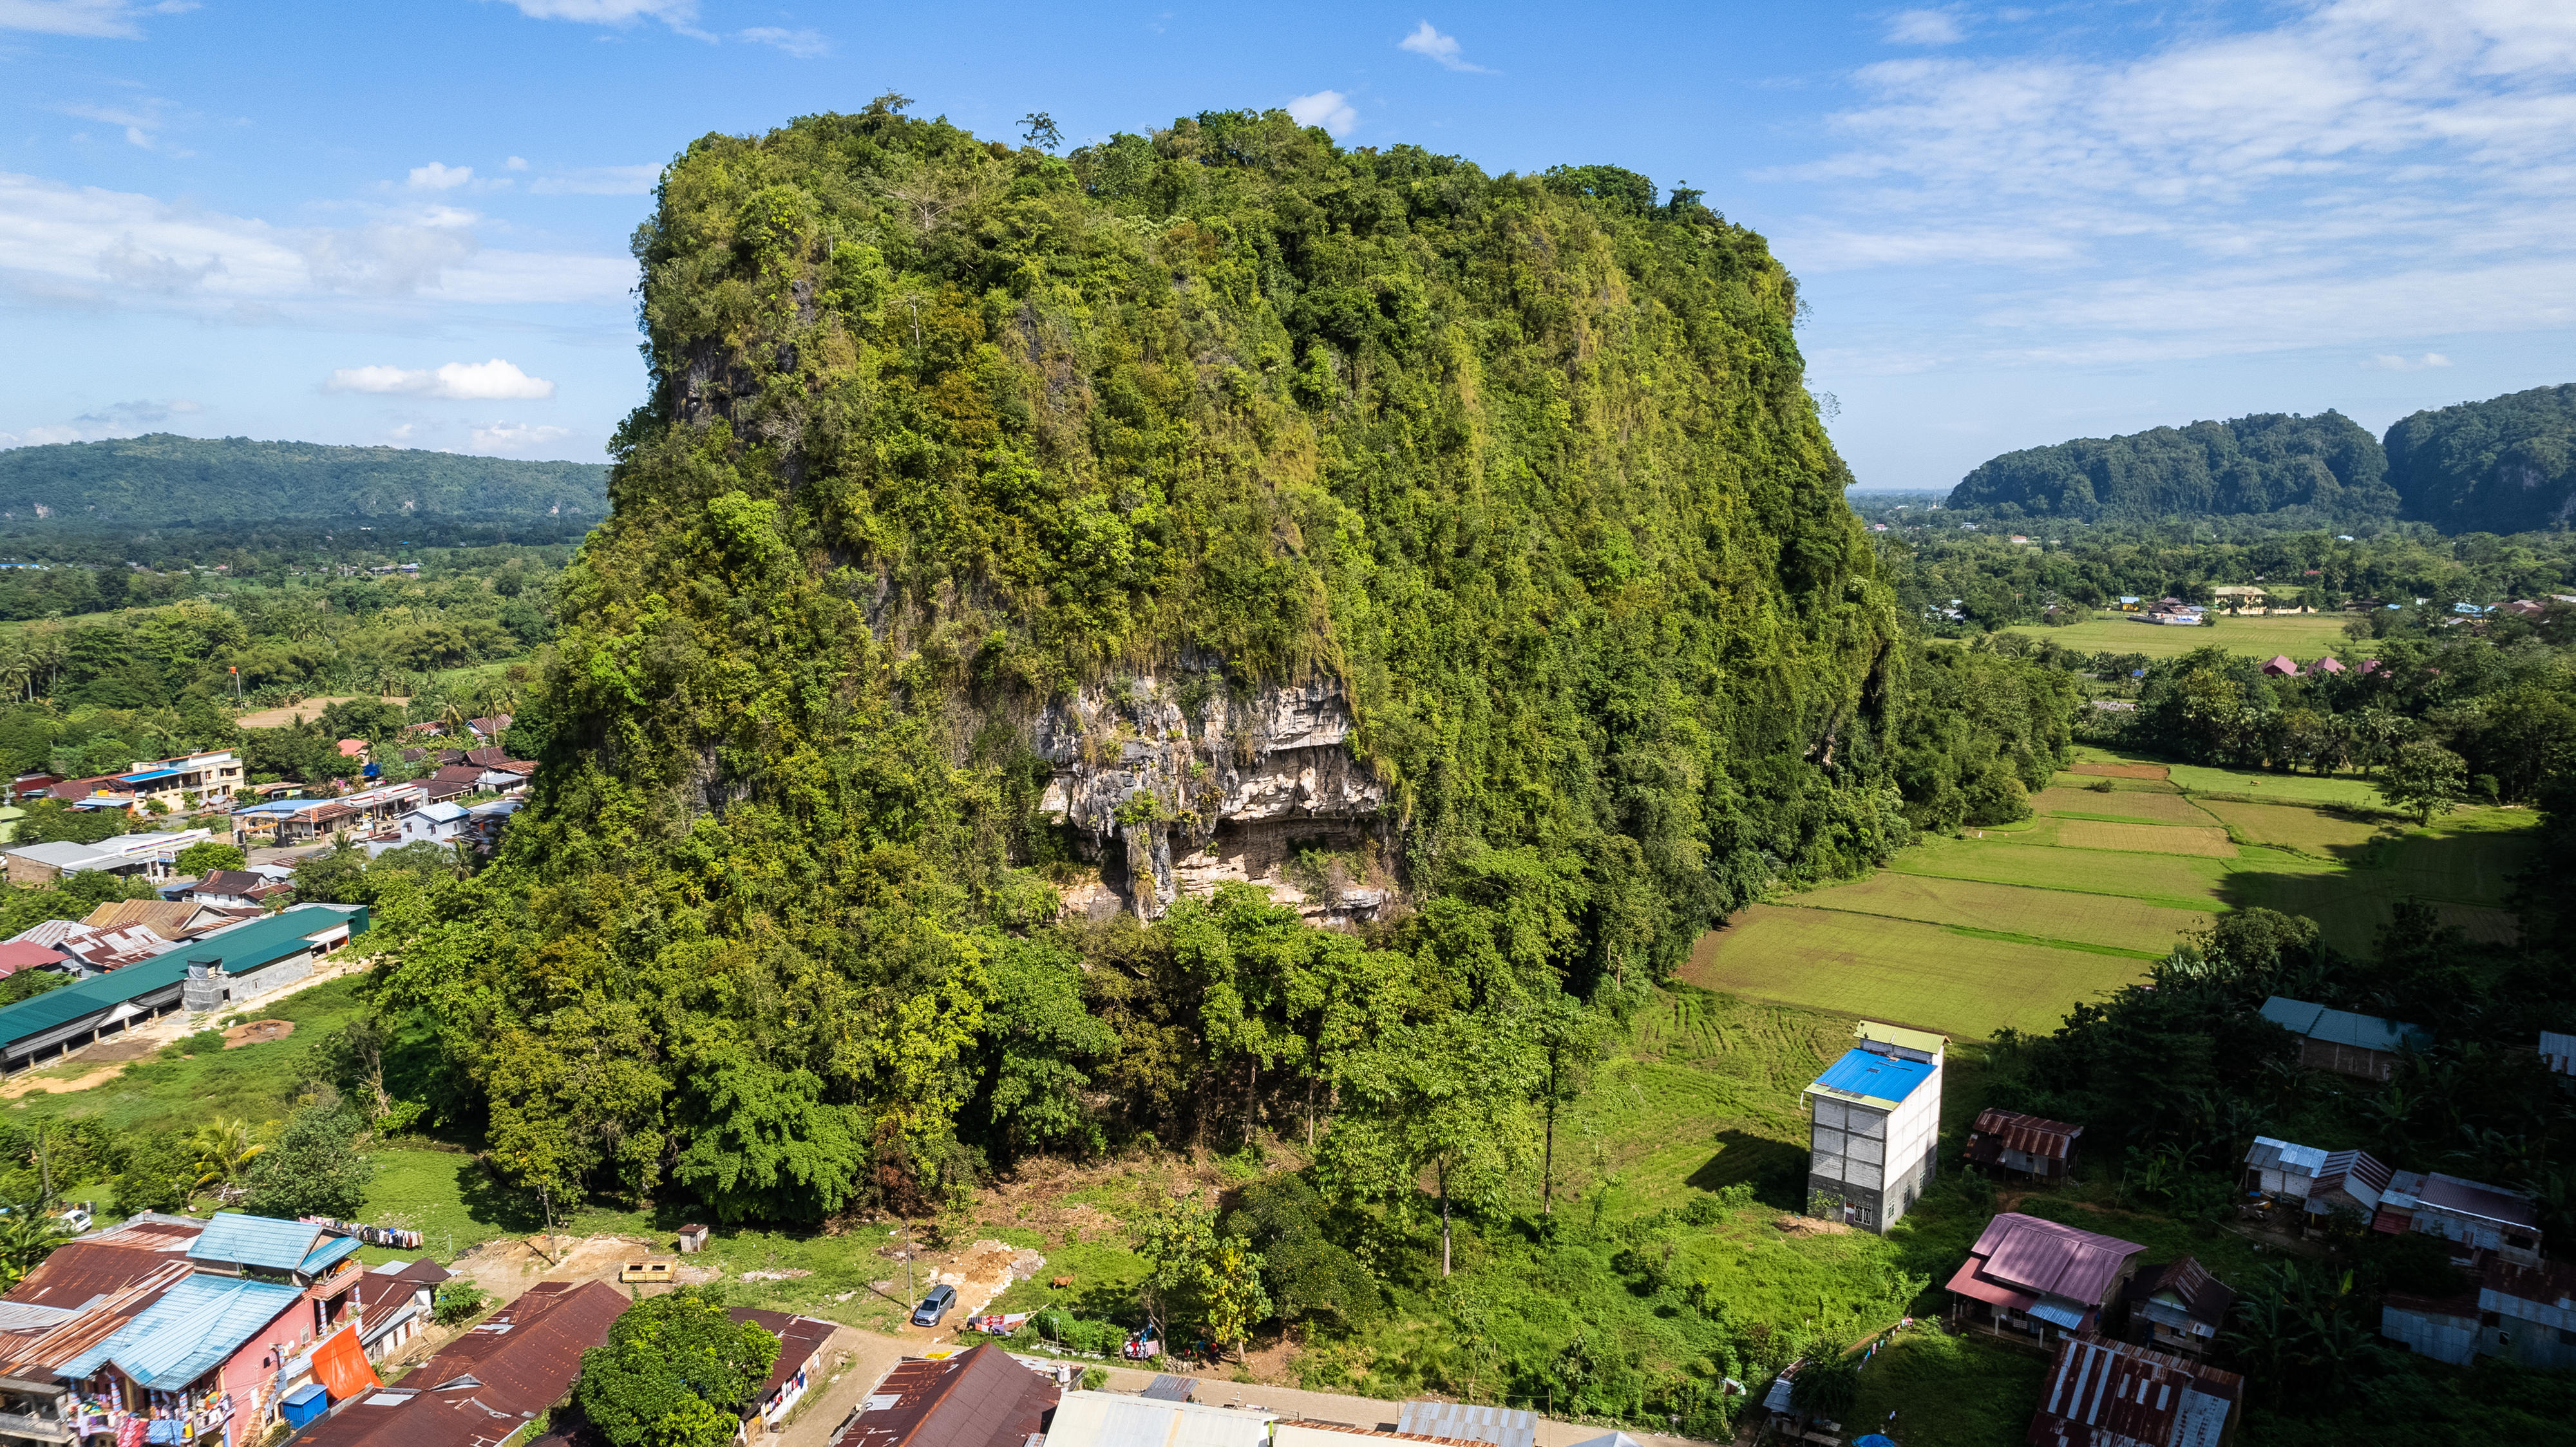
top-left (1680, 903), bottom-right (2146, 1037)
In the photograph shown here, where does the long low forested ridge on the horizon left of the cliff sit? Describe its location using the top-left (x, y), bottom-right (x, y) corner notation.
top-left (0, 433), bottom-right (608, 528)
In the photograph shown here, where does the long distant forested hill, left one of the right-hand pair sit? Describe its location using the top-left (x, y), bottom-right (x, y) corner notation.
top-left (1950, 412), bottom-right (2398, 520)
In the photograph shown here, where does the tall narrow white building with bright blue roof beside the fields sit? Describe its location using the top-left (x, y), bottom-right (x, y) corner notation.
top-left (1803, 1019), bottom-right (1950, 1236)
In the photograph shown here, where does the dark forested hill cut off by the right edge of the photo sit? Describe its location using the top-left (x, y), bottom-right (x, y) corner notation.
top-left (2388, 384), bottom-right (2576, 533)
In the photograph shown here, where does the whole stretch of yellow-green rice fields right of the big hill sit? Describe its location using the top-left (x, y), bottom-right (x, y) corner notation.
top-left (1680, 749), bottom-right (2537, 1037)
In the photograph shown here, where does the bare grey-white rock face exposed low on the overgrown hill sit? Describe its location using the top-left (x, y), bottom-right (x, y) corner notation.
top-left (1033, 672), bottom-right (1391, 924)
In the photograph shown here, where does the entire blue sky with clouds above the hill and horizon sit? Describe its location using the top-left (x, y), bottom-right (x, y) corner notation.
top-left (0, 0), bottom-right (2576, 487)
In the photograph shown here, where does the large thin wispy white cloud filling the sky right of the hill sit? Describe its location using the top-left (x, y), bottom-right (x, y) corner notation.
top-left (1759, 0), bottom-right (2576, 368)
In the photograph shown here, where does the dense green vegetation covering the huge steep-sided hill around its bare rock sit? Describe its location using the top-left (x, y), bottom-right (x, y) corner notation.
top-left (389, 98), bottom-right (1906, 1218)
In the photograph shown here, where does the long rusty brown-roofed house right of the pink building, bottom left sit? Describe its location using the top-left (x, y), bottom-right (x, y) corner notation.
top-left (286, 1282), bottom-right (629, 1447)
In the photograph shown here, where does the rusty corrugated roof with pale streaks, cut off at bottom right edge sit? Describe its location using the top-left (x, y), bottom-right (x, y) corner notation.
top-left (2025, 1336), bottom-right (2244, 1447)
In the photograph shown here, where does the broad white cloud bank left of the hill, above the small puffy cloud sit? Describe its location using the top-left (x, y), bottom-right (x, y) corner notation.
top-left (0, 173), bottom-right (634, 317)
